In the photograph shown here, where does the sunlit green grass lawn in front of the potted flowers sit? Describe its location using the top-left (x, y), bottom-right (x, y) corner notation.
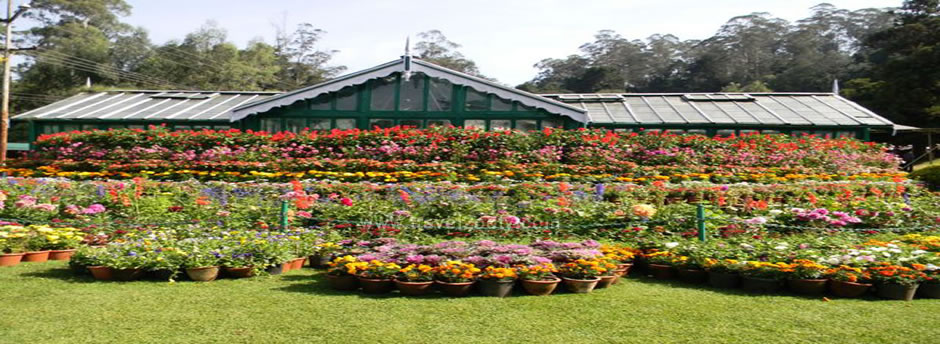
top-left (0, 262), bottom-right (940, 344)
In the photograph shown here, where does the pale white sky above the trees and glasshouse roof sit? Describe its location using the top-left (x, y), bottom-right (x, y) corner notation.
top-left (114, 0), bottom-right (901, 85)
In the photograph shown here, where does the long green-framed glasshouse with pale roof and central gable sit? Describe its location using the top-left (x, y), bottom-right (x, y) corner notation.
top-left (11, 56), bottom-right (894, 148)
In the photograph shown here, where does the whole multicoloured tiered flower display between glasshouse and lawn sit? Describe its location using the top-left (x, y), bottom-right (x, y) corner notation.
top-left (0, 127), bottom-right (940, 344)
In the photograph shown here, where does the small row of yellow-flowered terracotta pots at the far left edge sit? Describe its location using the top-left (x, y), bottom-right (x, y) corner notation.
top-left (0, 223), bottom-right (85, 267)
